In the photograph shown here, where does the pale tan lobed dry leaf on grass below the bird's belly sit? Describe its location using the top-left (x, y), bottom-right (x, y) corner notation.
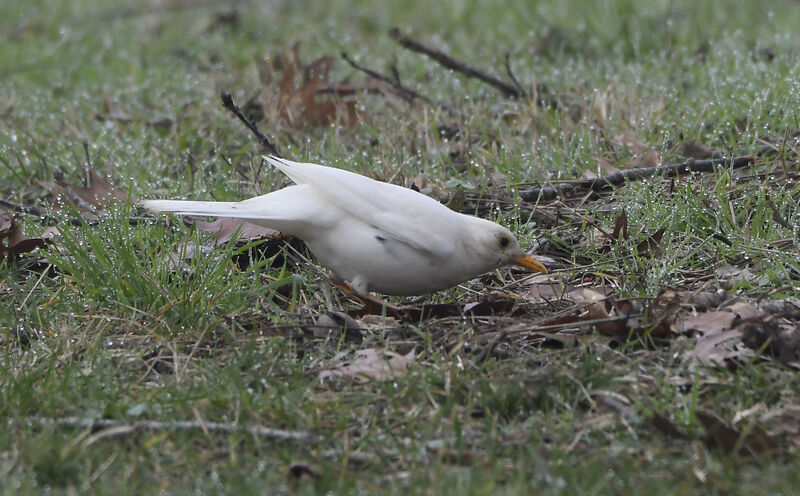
top-left (319, 348), bottom-right (416, 382)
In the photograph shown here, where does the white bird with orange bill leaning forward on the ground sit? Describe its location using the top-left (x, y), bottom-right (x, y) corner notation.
top-left (141, 156), bottom-right (547, 296)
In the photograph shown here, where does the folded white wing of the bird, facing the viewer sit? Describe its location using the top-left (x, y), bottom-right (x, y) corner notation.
top-left (264, 156), bottom-right (460, 256)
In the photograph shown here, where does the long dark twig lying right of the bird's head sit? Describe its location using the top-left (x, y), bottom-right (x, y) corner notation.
top-left (520, 155), bottom-right (758, 201)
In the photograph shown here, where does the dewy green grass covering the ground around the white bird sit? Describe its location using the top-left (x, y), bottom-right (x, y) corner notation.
top-left (0, 0), bottom-right (800, 495)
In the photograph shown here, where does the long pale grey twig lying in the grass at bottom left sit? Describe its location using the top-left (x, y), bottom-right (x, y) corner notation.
top-left (12, 416), bottom-right (325, 443)
